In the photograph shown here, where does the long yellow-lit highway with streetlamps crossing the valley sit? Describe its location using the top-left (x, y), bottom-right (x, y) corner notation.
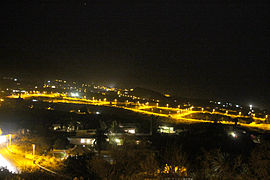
top-left (5, 93), bottom-right (270, 130)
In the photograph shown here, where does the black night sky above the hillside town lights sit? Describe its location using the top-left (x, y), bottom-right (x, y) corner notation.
top-left (0, 0), bottom-right (270, 106)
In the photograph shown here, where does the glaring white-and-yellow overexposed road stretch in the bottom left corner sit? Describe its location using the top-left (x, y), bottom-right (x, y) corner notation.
top-left (0, 147), bottom-right (35, 173)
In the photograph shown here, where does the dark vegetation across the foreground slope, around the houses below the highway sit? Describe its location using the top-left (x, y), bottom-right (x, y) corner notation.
top-left (0, 100), bottom-right (270, 179)
